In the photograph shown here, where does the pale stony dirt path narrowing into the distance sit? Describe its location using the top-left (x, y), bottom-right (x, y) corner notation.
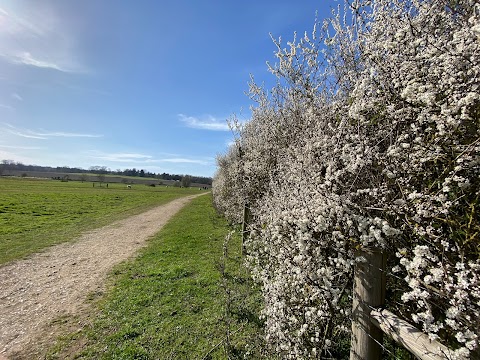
top-left (0, 195), bottom-right (204, 360)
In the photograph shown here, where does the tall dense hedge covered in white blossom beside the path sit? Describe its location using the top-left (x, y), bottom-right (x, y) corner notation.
top-left (213, 0), bottom-right (480, 359)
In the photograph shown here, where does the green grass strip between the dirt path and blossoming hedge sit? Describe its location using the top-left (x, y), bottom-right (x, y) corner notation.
top-left (47, 196), bottom-right (270, 359)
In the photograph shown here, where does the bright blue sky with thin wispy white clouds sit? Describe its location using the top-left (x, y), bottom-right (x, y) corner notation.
top-left (0, 0), bottom-right (338, 176)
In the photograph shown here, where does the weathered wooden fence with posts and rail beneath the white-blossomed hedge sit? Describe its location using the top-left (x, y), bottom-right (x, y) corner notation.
top-left (242, 204), bottom-right (460, 360)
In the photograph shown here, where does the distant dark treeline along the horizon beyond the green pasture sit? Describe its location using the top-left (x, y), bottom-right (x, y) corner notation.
top-left (0, 160), bottom-right (212, 185)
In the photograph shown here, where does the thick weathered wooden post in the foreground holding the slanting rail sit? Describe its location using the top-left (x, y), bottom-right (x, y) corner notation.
top-left (350, 249), bottom-right (386, 360)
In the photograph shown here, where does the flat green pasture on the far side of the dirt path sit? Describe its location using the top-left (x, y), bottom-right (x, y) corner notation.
top-left (0, 177), bottom-right (204, 264)
